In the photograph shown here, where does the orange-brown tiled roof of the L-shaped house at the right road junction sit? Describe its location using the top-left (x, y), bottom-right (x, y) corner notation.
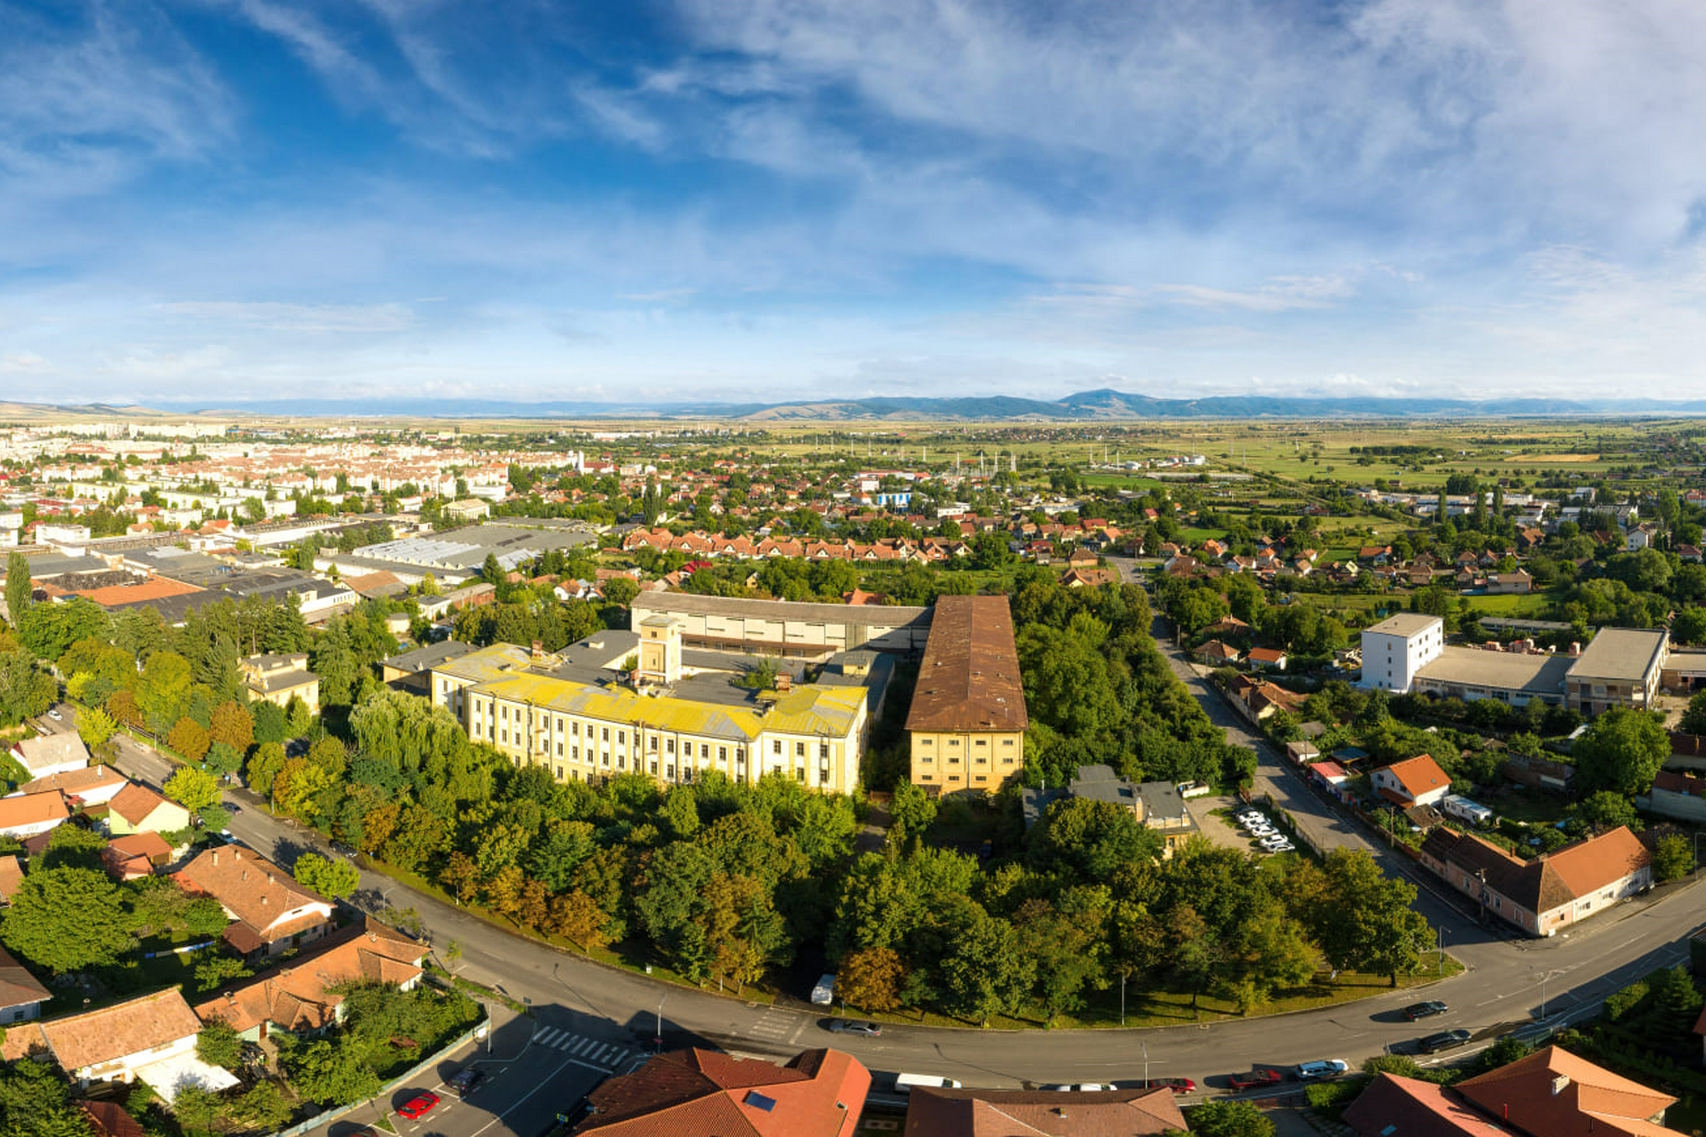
top-left (1421, 825), bottom-right (1651, 913)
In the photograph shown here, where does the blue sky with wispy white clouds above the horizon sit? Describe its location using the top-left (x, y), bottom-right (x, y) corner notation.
top-left (0, 0), bottom-right (1706, 406)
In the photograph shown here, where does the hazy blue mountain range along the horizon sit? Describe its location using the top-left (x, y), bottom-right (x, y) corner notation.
top-left (10, 388), bottom-right (1706, 423)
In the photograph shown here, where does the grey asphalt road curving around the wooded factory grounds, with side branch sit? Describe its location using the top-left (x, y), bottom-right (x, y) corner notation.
top-left (69, 628), bottom-right (1701, 1091)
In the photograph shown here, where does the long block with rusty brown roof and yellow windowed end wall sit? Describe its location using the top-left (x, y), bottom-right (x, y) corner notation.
top-left (906, 596), bottom-right (1029, 794)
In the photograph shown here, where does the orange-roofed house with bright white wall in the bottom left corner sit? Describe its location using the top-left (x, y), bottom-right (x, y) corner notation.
top-left (0, 987), bottom-right (237, 1101)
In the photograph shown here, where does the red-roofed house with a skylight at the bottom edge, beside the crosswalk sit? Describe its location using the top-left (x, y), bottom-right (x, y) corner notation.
top-left (573, 1048), bottom-right (870, 1137)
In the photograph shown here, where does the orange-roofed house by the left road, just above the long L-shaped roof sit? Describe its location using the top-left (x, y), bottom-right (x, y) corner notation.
top-left (174, 845), bottom-right (333, 956)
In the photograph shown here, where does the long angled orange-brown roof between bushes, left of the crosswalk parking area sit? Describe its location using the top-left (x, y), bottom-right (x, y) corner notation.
top-left (196, 920), bottom-right (427, 1031)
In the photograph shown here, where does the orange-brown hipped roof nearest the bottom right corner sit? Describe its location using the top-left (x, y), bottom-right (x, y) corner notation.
top-left (1457, 1047), bottom-right (1682, 1137)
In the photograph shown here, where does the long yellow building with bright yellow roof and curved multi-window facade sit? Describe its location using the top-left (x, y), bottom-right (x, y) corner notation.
top-left (432, 645), bottom-right (868, 794)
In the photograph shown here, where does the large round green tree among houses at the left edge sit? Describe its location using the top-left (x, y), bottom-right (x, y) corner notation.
top-left (0, 867), bottom-right (136, 975)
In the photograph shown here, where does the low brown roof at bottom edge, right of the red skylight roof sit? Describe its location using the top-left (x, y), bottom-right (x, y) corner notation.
top-left (906, 1087), bottom-right (1184, 1137)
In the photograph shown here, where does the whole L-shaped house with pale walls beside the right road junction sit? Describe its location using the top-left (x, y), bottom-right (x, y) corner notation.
top-left (1419, 826), bottom-right (1653, 936)
